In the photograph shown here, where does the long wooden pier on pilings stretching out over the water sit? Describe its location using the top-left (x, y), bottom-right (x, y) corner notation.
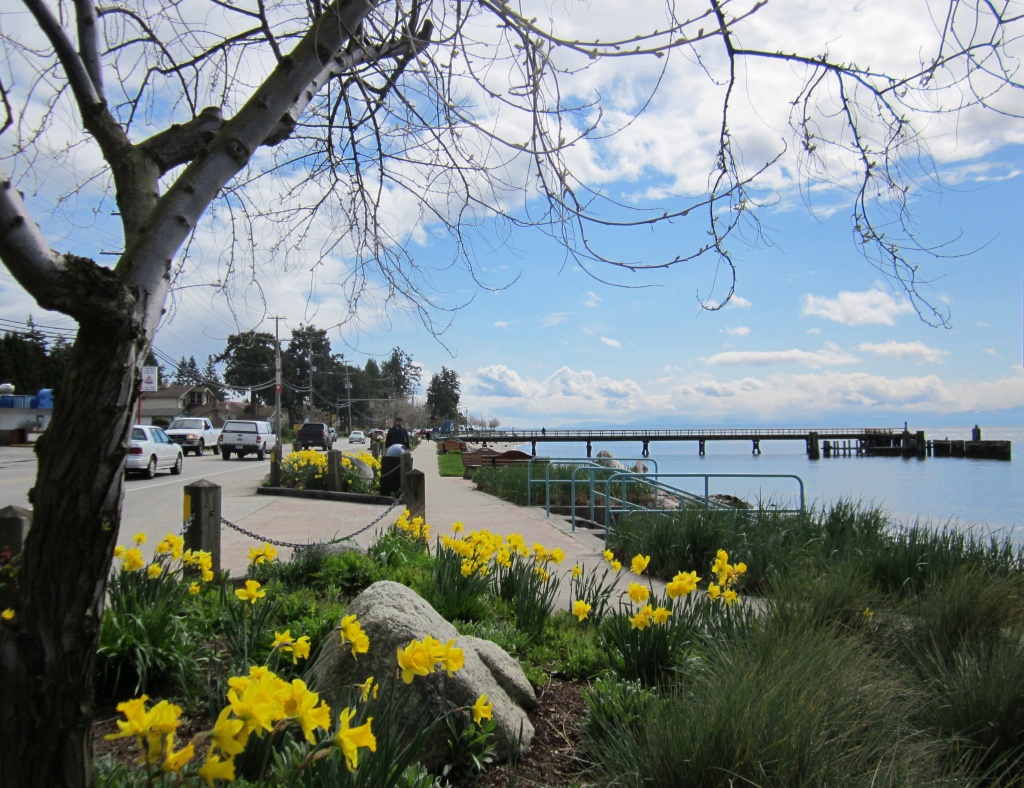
top-left (452, 425), bottom-right (1011, 459)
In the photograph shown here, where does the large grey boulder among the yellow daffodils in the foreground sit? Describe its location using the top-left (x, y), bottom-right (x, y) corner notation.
top-left (305, 580), bottom-right (537, 770)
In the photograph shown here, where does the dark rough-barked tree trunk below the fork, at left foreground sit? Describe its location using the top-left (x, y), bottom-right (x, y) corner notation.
top-left (0, 315), bottom-right (144, 788)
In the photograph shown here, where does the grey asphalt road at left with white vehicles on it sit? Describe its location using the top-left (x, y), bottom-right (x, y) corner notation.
top-left (0, 446), bottom-right (270, 544)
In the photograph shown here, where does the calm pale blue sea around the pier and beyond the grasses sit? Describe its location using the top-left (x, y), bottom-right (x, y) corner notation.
top-left (522, 426), bottom-right (1024, 544)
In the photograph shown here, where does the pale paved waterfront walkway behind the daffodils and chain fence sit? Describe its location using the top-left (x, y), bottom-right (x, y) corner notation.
top-left (221, 441), bottom-right (664, 608)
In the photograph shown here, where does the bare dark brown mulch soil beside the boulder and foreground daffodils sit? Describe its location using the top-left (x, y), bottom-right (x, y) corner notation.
top-left (92, 677), bottom-right (587, 788)
